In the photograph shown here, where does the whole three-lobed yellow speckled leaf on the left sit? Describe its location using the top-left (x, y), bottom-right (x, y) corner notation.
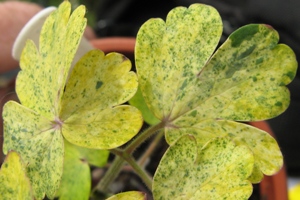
top-left (3, 1), bottom-right (142, 199)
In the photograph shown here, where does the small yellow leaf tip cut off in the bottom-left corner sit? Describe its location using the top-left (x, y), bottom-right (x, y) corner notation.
top-left (0, 151), bottom-right (34, 200)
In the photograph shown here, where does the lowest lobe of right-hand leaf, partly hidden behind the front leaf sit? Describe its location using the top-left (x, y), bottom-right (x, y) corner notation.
top-left (166, 119), bottom-right (283, 183)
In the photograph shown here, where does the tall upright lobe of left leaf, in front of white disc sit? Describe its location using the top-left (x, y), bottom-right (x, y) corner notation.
top-left (16, 1), bottom-right (86, 119)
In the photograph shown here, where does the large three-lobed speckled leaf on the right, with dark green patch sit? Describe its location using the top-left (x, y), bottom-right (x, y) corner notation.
top-left (135, 4), bottom-right (297, 182)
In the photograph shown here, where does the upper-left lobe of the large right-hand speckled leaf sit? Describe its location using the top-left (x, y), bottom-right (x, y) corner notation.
top-left (135, 4), bottom-right (222, 120)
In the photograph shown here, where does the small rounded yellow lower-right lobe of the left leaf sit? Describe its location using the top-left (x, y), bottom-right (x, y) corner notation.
top-left (62, 105), bottom-right (142, 149)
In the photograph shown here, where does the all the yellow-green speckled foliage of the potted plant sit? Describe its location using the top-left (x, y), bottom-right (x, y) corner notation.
top-left (0, 1), bottom-right (297, 199)
